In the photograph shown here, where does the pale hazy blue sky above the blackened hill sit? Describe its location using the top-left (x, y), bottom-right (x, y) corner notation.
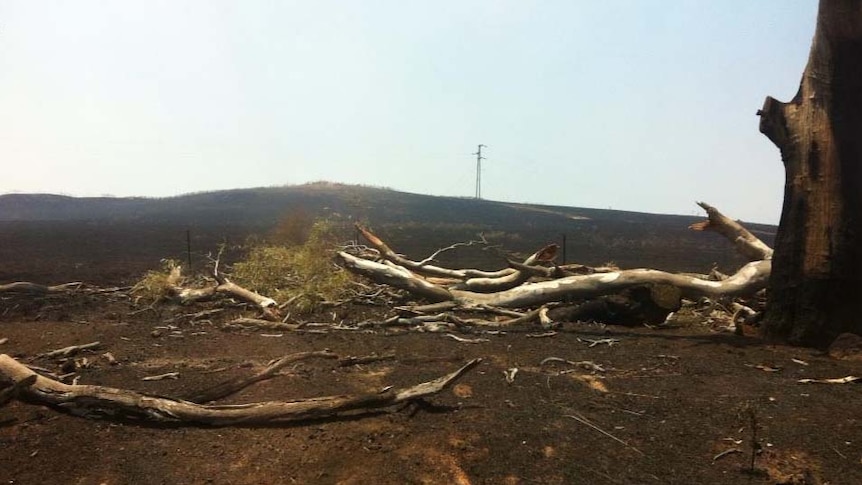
top-left (0, 0), bottom-right (817, 223)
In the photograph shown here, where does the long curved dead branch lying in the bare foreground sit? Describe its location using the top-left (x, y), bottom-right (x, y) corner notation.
top-left (0, 354), bottom-right (481, 426)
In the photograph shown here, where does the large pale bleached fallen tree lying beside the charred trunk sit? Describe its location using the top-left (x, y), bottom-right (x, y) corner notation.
top-left (338, 202), bottom-right (772, 324)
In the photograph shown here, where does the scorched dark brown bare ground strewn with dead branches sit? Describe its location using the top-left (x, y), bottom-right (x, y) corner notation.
top-left (0, 228), bottom-right (862, 484)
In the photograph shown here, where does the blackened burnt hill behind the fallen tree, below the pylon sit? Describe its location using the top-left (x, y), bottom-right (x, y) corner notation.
top-left (0, 182), bottom-right (775, 280)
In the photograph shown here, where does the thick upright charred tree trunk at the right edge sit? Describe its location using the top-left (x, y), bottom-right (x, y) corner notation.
top-left (758, 0), bottom-right (862, 347)
